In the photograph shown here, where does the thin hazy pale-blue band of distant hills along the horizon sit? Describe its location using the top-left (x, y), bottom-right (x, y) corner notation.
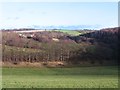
top-left (1, 25), bottom-right (101, 30)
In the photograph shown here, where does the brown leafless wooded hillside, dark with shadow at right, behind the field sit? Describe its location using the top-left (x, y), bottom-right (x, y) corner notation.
top-left (2, 27), bottom-right (120, 65)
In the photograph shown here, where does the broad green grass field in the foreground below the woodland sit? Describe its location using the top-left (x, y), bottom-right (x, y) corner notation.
top-left (2, 66), bottom-right (118, 88)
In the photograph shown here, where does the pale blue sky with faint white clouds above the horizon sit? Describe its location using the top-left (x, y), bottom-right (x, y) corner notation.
top-left (0, 2), bottom-right (118, 28)
